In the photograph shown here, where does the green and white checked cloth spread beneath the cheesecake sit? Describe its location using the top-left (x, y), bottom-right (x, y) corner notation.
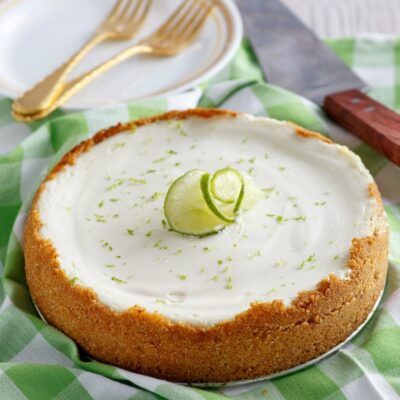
top-left (0, 36), bottom-right (400, 400)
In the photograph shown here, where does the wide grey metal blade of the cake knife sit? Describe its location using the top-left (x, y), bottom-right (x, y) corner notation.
top-left (236, 0), bottom-right (367, 105)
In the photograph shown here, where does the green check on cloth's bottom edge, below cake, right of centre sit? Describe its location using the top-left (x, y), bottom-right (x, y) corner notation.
top-left (272, 367), bottom-right (345, 400)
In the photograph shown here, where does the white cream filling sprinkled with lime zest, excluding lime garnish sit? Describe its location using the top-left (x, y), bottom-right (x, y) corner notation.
top-left (39, 115), bottom-right (376, 326)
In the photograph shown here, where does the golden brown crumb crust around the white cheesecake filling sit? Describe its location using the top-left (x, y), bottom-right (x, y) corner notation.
top-left (24, 109), bottom-right (388, 382)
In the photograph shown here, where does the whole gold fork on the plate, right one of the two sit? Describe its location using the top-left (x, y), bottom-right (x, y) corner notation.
top-left (13, 0), bottom-right (213, 122)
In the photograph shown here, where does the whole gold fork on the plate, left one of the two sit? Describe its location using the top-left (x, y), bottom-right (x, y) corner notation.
top-left (12, 0), bottom-right (153, 114)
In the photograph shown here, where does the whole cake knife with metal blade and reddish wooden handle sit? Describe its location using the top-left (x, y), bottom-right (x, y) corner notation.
top-left (236, 0), bottom-right (400, 166)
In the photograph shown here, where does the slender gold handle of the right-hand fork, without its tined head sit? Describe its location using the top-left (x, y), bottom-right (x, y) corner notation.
top-left (13, 44), bottom-right (153, 122)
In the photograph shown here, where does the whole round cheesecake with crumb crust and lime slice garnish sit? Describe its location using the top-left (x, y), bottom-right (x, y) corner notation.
top-left (24, 109), bottom-right (388, 382)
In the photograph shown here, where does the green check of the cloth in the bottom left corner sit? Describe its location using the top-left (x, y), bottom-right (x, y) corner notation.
top-left (5, 363), bottom-right (77, 400)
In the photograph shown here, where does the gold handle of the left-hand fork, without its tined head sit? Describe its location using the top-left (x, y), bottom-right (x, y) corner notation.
top-left (12, 33), bottom-right (109, 114)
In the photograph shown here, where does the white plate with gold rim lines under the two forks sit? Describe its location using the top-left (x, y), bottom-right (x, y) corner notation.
top-left (0, 0), bottom-right (243, 110)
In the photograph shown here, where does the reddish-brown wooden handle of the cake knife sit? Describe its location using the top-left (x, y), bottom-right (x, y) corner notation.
top-left (324, 90), bottom-right (400, 166)
